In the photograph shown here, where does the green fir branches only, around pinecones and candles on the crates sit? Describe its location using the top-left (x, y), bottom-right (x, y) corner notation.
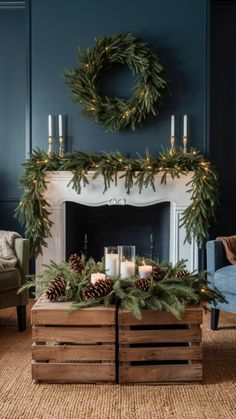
top-left (17, 258), bottom-right (226, 319)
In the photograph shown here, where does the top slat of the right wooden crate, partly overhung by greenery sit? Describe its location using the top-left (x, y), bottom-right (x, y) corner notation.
top-left (118, 306), bottom-right (203, 326)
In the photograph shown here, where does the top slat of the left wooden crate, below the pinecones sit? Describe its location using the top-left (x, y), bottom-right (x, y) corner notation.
top-left (31, 297), bottom-right (116, 326)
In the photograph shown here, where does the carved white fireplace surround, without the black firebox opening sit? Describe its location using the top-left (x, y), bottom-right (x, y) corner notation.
top-left (36, 171), bottom-right (198, 273)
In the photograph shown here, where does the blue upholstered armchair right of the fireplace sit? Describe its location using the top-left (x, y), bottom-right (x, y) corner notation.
top-left (206, 240), bottom-right (236, 330)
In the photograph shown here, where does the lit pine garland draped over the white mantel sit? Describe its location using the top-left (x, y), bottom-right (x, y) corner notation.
top-left (16, 149), bottom-right (219, 255)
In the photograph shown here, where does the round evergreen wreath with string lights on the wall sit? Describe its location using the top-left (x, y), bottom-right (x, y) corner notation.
top-left (64, 33), bottom-right (167, 132)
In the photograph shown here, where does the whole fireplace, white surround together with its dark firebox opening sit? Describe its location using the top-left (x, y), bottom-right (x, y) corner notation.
top-left (36, 171), bottom-right (198, 273)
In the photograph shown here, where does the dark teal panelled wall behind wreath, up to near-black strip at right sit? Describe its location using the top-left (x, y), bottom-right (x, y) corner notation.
top-left (0, 0), bottom-right (209, 233)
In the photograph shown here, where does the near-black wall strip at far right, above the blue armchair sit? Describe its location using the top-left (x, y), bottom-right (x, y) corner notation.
top-left (210, 0), bottom-right (236, 237)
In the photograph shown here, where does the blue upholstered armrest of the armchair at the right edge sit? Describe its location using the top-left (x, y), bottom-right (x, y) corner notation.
top-left (206, 240), bottom-right (229, 283)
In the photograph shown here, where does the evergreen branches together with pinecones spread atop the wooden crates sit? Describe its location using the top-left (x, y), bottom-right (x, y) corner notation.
top-left (18, 256), bottom-right (225, 318)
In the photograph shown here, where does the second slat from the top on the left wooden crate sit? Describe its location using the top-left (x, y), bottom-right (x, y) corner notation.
top-left (32, 326), bottom-right (115, 343)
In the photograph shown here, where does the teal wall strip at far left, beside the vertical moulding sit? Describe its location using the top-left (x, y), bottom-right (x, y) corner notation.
top-left (0, 2), bottom-right (26, 230)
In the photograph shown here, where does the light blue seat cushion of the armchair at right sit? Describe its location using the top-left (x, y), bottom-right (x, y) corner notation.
top-left (214, 265), bottom-right (236, 294)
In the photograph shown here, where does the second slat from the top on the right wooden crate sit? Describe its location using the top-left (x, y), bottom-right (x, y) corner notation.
top-left (119, 326), bottom-right (201, 344)
